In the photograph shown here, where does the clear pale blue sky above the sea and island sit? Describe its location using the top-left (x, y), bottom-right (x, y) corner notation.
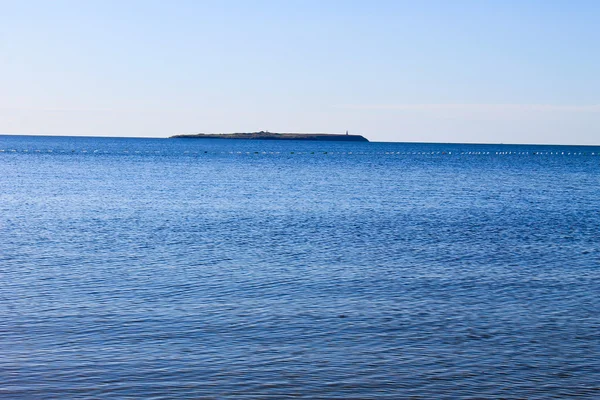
top-left (0, 0), bottom-right (600, 144)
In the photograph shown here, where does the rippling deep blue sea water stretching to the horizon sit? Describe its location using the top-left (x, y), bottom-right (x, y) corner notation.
top-left (0, 136), bottom-right (600, 399)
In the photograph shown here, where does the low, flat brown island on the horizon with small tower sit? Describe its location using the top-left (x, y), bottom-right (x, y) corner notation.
top-left (171, 131), bottom-right (369, 142)
